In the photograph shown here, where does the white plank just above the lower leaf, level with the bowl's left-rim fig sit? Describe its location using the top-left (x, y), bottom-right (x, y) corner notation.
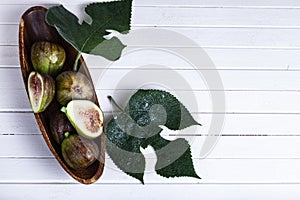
top-left (0, 68), bottom-right (300, 93)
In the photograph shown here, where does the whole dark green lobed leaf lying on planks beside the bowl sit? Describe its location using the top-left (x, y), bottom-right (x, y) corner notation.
top-left (105, 90), bottom-right (199, 183)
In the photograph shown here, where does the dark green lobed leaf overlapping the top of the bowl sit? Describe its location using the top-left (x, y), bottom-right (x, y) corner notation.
top-left (46, 0), bottom-right (132, 60)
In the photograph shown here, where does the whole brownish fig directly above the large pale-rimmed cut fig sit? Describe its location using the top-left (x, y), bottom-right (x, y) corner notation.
top-left (56, 71), bottom-right (94, 105)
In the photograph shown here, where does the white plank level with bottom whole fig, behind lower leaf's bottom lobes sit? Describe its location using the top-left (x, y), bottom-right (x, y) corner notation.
top-left (0, 132), bottom-right (300, 159)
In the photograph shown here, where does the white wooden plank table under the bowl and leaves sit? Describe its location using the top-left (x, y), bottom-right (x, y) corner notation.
top-left (0, 0), bottom-right (300, 200)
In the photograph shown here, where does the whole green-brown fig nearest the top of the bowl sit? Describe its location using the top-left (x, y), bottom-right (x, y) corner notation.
top-left (31, 41), bottom-right (66, 77)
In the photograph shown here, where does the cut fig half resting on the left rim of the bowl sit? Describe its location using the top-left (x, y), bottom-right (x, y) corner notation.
top-left (27, 71), bottom-right (55, 113)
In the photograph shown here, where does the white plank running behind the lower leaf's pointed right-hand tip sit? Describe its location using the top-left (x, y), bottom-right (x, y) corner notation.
top-left (0, 112), bottom-right (300, 136)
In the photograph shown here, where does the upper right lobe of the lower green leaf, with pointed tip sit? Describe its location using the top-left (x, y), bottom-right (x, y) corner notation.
top-left (127, 90), bottom-right (200, 130)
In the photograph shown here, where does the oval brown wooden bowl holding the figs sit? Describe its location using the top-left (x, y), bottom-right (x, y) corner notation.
top-left (19, 6), bottom-right (105, 184)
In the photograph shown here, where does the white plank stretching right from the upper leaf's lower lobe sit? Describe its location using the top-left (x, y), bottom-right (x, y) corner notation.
top-left (120, 27), bottom-right (300, 48)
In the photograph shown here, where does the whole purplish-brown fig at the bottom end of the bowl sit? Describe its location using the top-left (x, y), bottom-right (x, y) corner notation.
top-left (61, 134), bottom-right (99, 169)
